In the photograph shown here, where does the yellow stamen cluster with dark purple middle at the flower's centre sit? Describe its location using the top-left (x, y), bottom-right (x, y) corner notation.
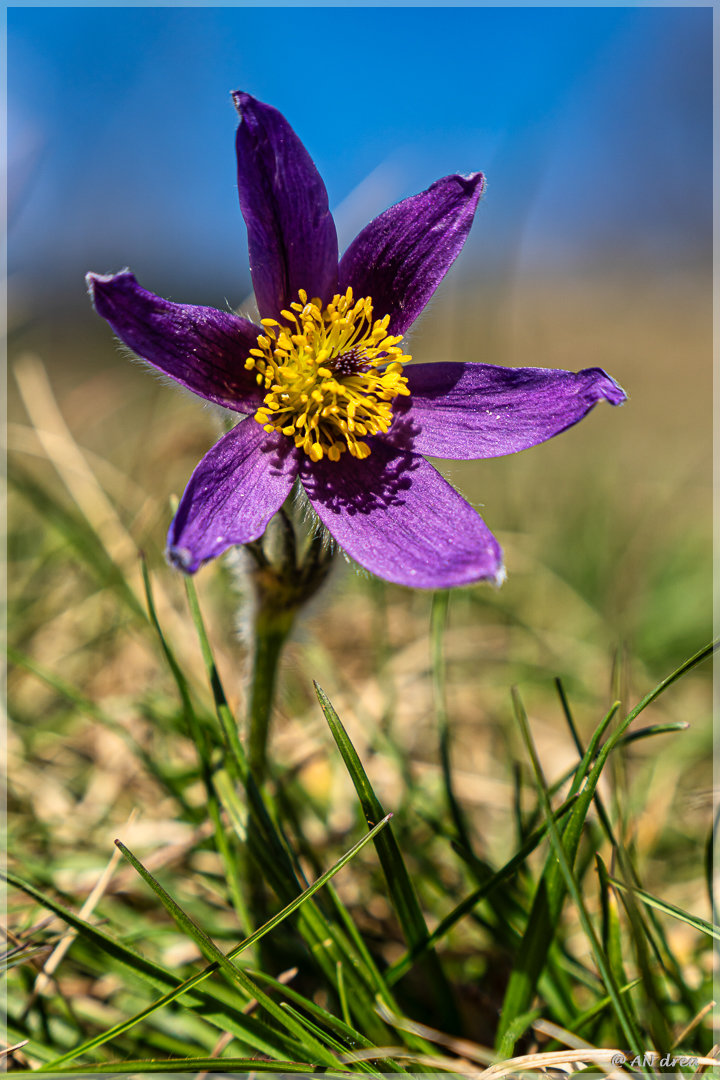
top-left (245, 288), bottom-right (411, 461)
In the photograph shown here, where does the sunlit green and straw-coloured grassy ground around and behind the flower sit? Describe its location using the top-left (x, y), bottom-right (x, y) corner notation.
top-left (6, 270), bottom-right (711, 1071)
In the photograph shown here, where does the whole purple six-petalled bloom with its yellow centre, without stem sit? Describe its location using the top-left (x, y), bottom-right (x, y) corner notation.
top-left (87, 93), bottom-right (625, 588)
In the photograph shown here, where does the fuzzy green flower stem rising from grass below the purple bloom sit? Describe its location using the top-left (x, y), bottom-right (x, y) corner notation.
top-left (247, 610), bottom-right (293, 786)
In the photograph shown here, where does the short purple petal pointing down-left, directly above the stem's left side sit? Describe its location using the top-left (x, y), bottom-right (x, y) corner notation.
top-left (167, 417), bottom-right (298, 573)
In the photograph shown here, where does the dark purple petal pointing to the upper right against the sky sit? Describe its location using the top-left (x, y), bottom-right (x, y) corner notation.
top-left (339, 173), bottom-right (485, 334)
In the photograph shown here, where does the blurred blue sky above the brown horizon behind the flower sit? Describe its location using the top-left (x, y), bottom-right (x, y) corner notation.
top-left (8, 6), bottom-right (711, 303)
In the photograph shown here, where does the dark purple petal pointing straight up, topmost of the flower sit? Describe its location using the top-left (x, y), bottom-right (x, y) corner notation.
top-left (232, 92), bottom-right (338, 318)
